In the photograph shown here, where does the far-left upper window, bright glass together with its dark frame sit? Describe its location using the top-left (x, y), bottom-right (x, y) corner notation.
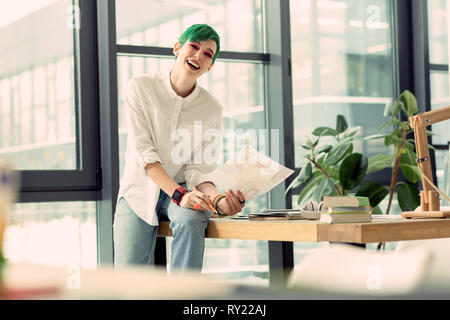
top-left (0, 0), bottom-right (98, 195)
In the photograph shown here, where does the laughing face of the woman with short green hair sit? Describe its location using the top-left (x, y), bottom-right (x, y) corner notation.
top-left (173, 39), bottom-right (217, 79)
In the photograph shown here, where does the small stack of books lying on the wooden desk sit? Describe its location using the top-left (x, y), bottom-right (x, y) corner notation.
top-left (319, 196), bottom-right (373, 223)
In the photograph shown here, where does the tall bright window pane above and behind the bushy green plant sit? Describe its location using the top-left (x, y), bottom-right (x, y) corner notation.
top-left (290, 0), bottom-right (394, 167)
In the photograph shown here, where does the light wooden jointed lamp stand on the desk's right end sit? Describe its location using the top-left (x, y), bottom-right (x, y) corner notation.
top-left (402, 106), bottom-right (450, 218)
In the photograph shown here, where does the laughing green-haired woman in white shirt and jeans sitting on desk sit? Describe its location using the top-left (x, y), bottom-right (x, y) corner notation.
top-left (114, 24), bottom-right (245, 270)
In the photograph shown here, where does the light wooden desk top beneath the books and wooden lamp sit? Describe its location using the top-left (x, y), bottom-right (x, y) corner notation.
top-left (158, 218), bottom-right (450, 243)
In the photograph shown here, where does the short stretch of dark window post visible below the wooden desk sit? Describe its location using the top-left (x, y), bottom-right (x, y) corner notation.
top-left (269, 241), bottom-right (294, 288)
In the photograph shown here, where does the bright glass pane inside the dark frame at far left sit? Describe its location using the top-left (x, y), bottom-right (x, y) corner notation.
top-left (0, 0), bottom-right (77, 170)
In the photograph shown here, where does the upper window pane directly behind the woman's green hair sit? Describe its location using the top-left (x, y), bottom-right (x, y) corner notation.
top-left (116, 0), bottom-right (264, 52)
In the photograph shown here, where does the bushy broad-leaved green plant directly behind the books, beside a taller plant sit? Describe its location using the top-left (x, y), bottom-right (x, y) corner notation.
top-left (286, 115), bottom-right (389, 213)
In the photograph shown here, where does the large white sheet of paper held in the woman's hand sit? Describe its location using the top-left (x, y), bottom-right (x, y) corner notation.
top-left (208, 145), bottom-right (294, 200)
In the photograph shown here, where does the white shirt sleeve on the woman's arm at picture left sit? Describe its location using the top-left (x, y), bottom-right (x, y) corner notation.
top-left (125, 78), bottom-right (161, 175)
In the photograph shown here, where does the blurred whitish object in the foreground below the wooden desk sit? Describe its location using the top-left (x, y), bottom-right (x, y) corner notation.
top-left (289, 245), bottom-right (430, 296)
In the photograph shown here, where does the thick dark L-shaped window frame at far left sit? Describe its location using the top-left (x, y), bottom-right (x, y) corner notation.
top-left (18, 0), bottom-right (101, 202)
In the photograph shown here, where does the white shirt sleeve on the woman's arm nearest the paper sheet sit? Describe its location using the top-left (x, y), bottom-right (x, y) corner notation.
top-left (183, 114), bottom-right (223, 190)
